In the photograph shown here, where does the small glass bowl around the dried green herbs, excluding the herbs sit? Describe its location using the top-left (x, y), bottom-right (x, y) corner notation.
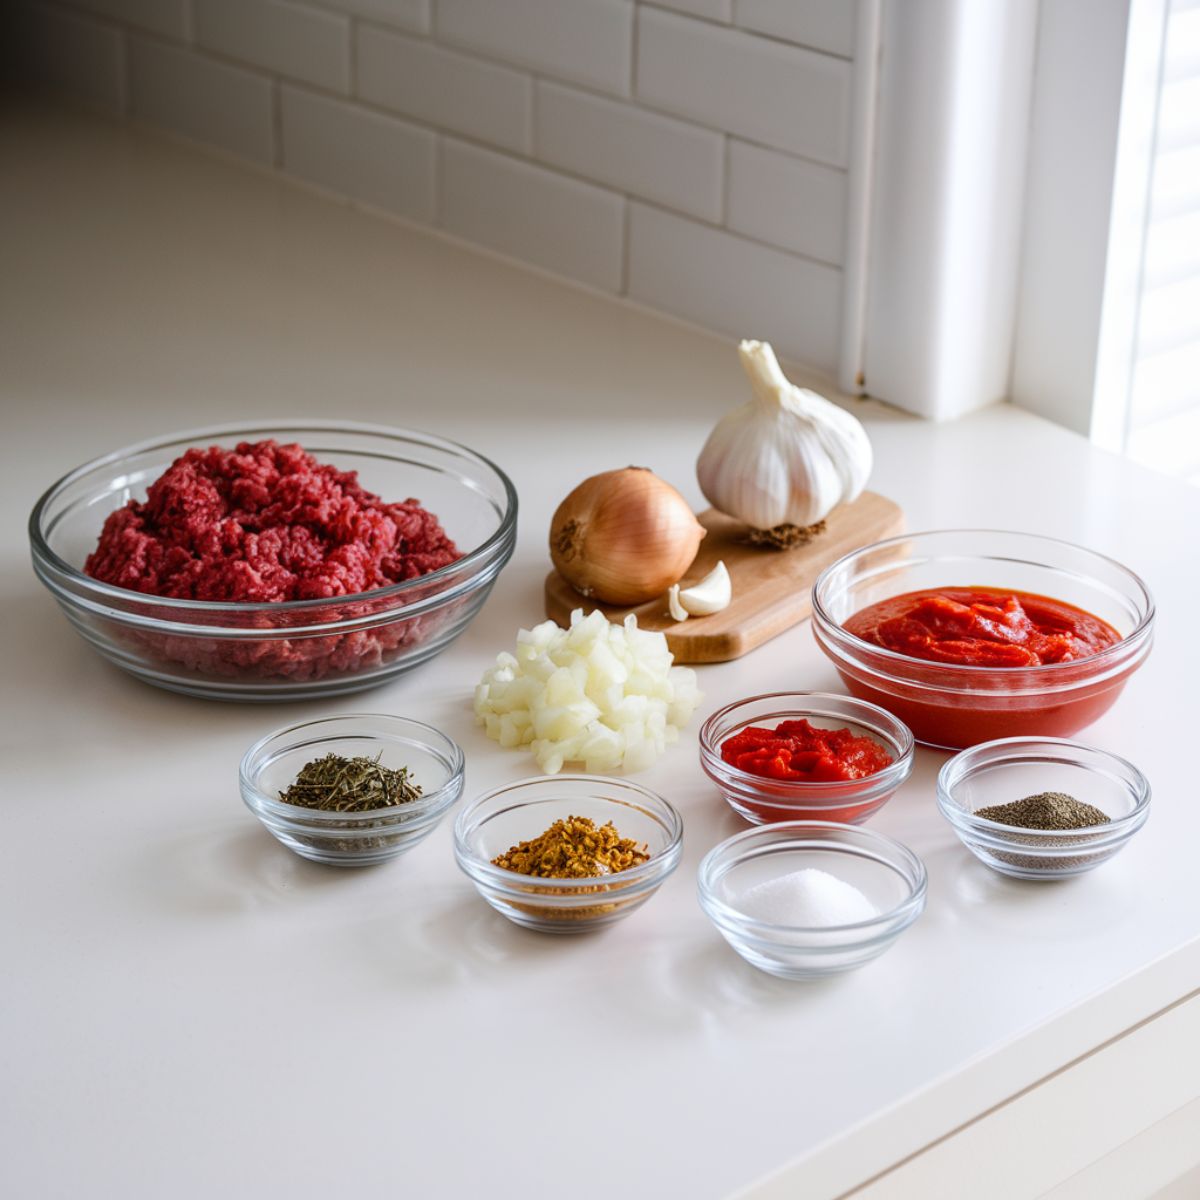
top-left (239, 713), bottom-right (466, 866)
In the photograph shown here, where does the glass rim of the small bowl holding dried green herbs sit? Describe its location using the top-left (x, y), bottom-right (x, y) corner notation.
top-left (238, 713), bottom-right (467, 828)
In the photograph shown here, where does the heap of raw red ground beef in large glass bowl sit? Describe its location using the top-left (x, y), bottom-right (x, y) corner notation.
top-left (84, 440), bottom-right (462, 678)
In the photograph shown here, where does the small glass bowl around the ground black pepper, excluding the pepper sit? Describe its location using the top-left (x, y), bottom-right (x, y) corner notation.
top-left (937, 738), bottom-right (1150, 880)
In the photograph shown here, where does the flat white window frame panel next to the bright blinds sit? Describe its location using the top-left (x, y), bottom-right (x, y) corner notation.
top-left (1012, 0), bottom-right (1169, 451)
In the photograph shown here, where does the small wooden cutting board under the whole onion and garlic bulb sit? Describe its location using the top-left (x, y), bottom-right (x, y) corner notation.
top-left (546, 492), bottom-right (904, 662)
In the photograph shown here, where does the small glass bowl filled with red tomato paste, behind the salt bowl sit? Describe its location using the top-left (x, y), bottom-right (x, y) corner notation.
top-left (700, 691), bottom-right (913, 824)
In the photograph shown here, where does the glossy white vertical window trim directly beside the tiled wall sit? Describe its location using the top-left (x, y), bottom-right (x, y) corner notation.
top-left (839, 0), bottom-right (1038, 419)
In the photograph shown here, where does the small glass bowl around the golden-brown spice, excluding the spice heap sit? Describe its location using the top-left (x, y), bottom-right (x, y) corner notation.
top-left (454, 775), bottom-right (683, 934)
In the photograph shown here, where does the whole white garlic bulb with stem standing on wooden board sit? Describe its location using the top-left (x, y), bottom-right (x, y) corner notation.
top-left (696, 342), bottom-right (872, 529)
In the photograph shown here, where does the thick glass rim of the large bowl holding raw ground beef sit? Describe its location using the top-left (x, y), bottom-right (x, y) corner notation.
top-left (29, 418), bottom-right (517, 624)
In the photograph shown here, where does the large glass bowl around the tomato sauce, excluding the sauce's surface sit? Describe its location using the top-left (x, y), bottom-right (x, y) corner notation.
top-left (812, 529), bottom-right (1154, 750)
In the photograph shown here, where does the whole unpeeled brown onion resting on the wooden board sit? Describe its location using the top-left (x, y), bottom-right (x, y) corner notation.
top-left (550, 467), bottom-right (706, 605)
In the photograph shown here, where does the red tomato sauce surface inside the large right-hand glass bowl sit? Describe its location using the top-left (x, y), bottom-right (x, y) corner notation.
top-left (845, 588), bottom-right (1121, 667)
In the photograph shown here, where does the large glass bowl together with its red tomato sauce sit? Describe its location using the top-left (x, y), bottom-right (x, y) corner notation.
top-left (812, 529), bottom-right (1154, 750)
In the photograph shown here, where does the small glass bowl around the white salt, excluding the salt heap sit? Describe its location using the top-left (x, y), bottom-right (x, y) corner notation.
top-left (697, 821), bottom-right (925, 979)
